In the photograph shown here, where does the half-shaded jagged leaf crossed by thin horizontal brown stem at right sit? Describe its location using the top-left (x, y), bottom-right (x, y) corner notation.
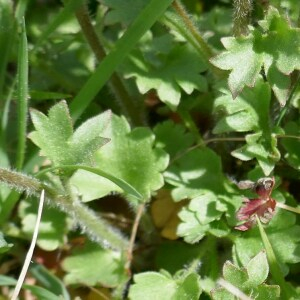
top-left (213, 76), bottom-right (280, 176)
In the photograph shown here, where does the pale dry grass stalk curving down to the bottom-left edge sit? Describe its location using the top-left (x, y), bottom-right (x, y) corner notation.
top-left (11, 190), bottom-right (45, 300)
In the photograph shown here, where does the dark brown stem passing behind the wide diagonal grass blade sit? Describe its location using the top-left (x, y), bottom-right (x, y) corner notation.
top-left (75, 5), bottom-right (145, 126)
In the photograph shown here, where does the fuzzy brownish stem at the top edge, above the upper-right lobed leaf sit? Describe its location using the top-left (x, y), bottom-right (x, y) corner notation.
top-left (233, 0), bottom-right (252, 36)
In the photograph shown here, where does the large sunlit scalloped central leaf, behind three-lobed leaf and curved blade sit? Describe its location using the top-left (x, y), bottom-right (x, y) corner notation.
top-left (73, 115), bottom-right (168, 201)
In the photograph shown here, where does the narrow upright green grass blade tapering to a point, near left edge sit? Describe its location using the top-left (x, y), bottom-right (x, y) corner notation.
top-left (16, 19), bottom-right (28, 170)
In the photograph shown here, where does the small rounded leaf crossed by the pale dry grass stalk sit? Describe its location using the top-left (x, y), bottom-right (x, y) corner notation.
top-left (19, 199), bottom-right (67, 251)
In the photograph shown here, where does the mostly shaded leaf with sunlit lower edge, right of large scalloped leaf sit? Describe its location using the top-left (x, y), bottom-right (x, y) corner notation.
top-left (165, 148), bottom-right (224, 201)
